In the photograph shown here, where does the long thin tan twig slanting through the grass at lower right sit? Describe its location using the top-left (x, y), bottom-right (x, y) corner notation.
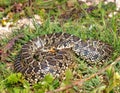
top-left (46, 57), bottom-right (120, 93)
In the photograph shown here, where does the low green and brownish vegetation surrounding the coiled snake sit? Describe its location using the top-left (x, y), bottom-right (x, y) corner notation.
top-left (0, 0), bottom-right (120, 93)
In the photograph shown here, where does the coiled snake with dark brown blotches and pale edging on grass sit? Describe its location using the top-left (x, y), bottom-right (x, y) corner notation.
top-left (14, 32), bottom-right (113, 83)
